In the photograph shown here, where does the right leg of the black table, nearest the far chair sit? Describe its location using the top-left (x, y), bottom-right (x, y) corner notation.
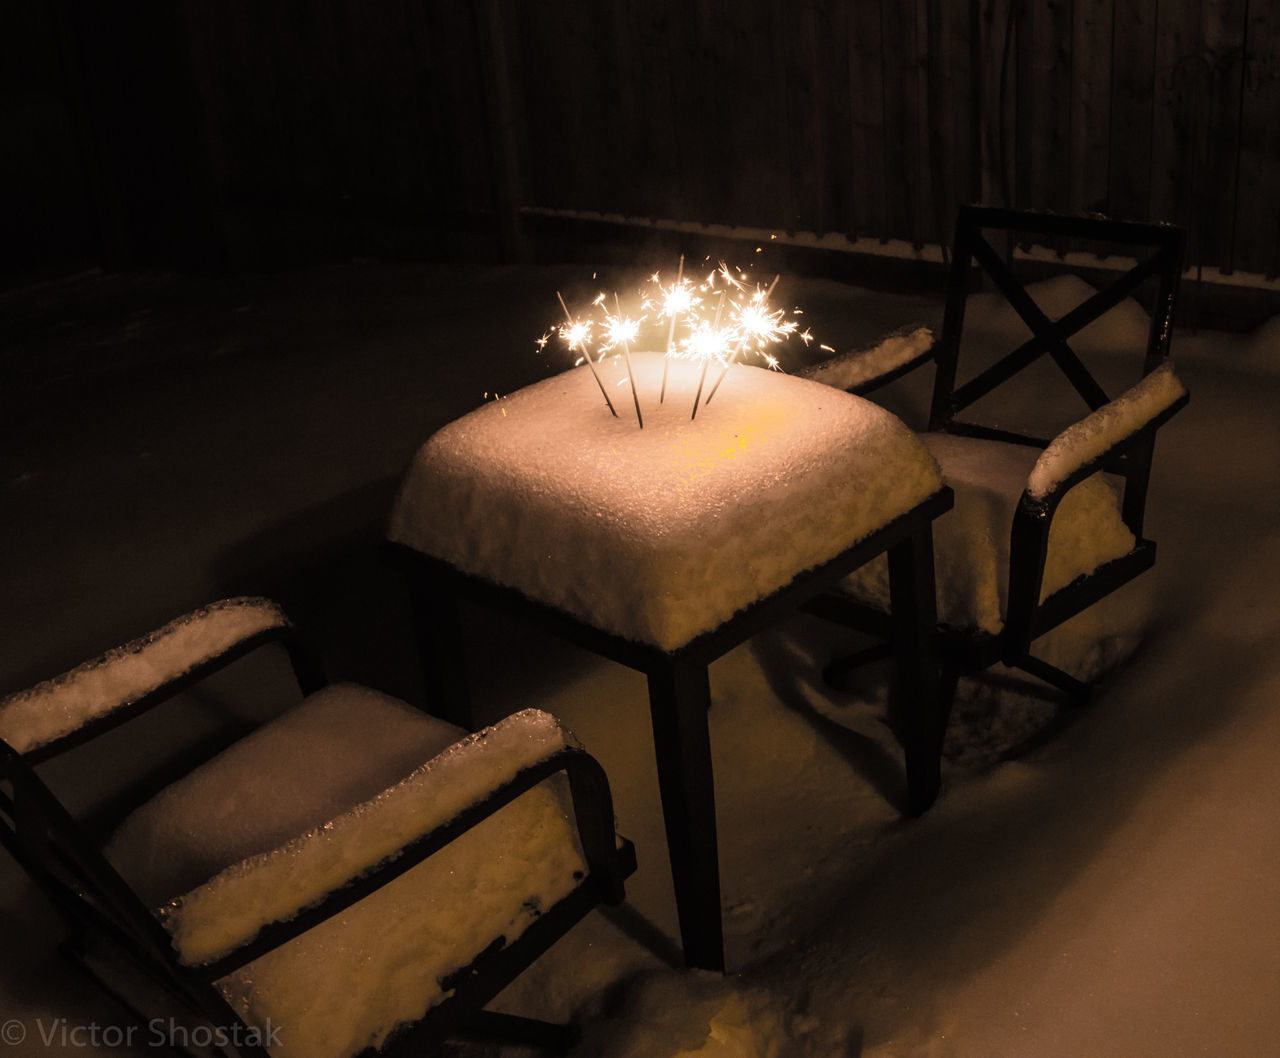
top-left (888, 526), bottom-right (946, 815)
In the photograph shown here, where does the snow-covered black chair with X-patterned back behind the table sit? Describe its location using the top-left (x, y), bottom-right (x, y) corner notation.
top-left (808, 206), bottom-right (1188, 793)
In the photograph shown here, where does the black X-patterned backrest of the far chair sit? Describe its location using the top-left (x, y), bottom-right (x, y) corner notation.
top-left (929, 206), bottom-right (1185, 446)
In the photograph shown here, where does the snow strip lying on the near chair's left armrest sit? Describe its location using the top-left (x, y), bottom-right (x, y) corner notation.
top-left (0, 597), bottom-right (289, 754)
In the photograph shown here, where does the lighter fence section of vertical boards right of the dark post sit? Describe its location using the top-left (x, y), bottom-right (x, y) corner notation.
top-left (499, 0), bottom-right (1280, 276)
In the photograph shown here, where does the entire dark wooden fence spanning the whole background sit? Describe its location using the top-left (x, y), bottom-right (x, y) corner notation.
top-left (0, 0), bottom-right (1280, 284)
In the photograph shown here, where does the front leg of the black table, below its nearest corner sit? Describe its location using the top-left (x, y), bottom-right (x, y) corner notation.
top-left (649, 661), bottom-right (724, 972)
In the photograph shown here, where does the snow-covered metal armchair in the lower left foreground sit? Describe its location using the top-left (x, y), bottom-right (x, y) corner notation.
top-left (0, 599), bottom-right (635, 1058)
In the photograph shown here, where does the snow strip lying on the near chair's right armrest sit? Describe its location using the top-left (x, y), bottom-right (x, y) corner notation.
top-left (161, 709), bottom-right (577, 966)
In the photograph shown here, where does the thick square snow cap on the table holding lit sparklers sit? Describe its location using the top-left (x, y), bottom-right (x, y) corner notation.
top-left (389, 353), bottom-right (940, 650)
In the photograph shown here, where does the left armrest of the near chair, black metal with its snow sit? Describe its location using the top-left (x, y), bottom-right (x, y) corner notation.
top-left (0, 596), bottom-right (323, 759)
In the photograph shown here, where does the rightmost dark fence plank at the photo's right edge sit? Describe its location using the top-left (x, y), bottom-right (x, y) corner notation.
top-left (1231, 3), bottom-right (1280, 279)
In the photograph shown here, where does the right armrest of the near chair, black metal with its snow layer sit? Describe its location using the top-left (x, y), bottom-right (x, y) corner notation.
top-left (160, 709), bottom-right (622, 979)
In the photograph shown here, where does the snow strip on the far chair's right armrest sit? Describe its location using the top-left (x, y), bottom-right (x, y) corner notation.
top-left (1027, 362), bottom-right (1187, 503)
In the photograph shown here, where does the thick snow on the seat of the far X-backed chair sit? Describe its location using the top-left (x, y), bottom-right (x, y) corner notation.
top-left (841, 434), bottom-right (1137, 635)
